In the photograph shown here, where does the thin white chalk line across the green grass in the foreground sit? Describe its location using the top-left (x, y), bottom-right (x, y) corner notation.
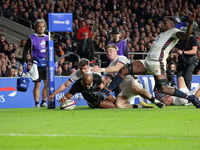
top-left (0, 133), bottom-right (200, 140)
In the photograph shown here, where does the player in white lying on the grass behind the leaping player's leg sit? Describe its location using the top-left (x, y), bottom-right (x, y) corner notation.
top-left (154, 77), bottom-right (200, 106)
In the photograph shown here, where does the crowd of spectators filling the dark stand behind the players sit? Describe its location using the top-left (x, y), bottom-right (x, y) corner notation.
top-left (0, 0), bottom-right (200, 77)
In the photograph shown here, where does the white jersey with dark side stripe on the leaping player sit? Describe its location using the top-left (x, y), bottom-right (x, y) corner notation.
top-left (146, 28), bottom-right (180, 62)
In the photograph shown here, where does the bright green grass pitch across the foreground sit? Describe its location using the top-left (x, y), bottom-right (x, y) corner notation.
top-left (0, 106), bottom-right (200, 150)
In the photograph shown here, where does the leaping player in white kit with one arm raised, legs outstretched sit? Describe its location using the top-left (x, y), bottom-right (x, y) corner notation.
top-left (94, 10), bottom-right (200, 108)
